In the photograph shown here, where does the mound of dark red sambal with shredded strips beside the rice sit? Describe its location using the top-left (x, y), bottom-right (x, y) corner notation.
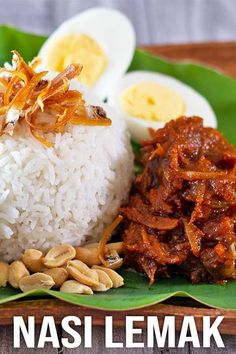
top-left (121, 117), bottom-right (236, 283)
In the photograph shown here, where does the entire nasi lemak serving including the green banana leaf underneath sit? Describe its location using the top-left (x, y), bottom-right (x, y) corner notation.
top-left (0, 8), bottom-right (236, 320)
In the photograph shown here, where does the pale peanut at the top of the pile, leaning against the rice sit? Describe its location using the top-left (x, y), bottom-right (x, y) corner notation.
top-left (43, 244), bottom-right (76, 268)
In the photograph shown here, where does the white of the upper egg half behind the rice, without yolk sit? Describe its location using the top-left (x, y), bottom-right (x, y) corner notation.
top-left (39, 7), bottom-right (135, 99)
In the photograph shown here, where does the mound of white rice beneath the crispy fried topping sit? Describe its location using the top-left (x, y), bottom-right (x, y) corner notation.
top-left (0, 83), bottom-right (133, 261)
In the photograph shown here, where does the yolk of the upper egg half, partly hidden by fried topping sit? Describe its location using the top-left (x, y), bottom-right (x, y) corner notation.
top-left (46, 34), bottom-right (108, 86)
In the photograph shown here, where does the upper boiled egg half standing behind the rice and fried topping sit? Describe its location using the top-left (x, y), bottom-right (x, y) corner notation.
top-left (39, 7), bottom-right (135, 98)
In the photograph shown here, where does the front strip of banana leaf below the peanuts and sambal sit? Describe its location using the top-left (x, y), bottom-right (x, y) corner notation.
top-left (0, 270), bottom-right (236, 311)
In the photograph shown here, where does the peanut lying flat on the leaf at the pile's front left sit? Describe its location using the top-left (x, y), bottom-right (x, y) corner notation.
top-left (19, 273), bottom-right (55, 293)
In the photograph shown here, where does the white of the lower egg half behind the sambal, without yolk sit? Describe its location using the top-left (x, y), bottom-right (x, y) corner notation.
top-left (108, 71), bottom-right (217, 142)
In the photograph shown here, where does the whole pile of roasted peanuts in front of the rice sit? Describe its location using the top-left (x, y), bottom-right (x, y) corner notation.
top-left (0, 242), bottom-right (124, 295)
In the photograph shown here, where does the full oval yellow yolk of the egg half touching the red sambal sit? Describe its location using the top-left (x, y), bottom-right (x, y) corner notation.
top-left (120, 82), bottom-right (185, 122)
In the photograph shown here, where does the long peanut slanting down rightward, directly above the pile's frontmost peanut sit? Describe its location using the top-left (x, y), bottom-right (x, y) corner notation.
top-left (66, 260), bottom-right (99, 286)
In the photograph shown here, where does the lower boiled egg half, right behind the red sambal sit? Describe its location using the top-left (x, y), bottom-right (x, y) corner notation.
top-left (108, 71), bottom-right (217, 142)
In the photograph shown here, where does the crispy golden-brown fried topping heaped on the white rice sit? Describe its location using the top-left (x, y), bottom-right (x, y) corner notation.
top-left (0, 51), bottom-right (111, 147)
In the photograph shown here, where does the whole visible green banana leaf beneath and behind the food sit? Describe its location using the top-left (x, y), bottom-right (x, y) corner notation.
top-left (0, 26), bottom-right (236, 310)
